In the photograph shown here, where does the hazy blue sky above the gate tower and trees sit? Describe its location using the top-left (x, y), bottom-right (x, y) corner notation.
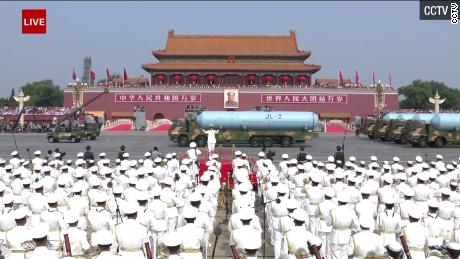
top-left (0, 1), bottom-right (460, 96)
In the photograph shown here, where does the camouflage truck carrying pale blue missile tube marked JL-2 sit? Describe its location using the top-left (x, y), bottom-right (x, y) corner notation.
top-left (168, 111), bottom-right (318, 147)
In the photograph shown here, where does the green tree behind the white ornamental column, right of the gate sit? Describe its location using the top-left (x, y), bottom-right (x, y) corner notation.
top-left (398, 80), bottom-right (460, 110)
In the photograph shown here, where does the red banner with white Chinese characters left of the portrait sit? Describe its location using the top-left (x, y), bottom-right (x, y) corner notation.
top-left (115, 93), bottom-right (201, 103)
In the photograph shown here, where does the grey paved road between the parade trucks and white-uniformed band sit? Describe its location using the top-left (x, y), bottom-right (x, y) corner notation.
top-left (0, 132), bottom-right (460, 161)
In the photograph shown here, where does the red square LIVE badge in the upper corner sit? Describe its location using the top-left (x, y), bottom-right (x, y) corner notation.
top-left (22, 9), bottom-right (46, 34)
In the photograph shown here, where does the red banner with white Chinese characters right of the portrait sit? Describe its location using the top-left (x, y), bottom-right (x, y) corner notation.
top-left (260, 94), bottom-right (348, 104)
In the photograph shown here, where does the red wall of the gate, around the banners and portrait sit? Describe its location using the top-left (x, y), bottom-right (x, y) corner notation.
top-left (64, 89), bottom-right (399, 120)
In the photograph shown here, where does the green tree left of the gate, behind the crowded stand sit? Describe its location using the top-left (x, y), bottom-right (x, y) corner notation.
top-left (21, 80), bottom-right (64, 106)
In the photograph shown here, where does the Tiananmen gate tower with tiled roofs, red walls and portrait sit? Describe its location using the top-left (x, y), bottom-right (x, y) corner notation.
top-left (64, 31), bottom-right (399, 120)
